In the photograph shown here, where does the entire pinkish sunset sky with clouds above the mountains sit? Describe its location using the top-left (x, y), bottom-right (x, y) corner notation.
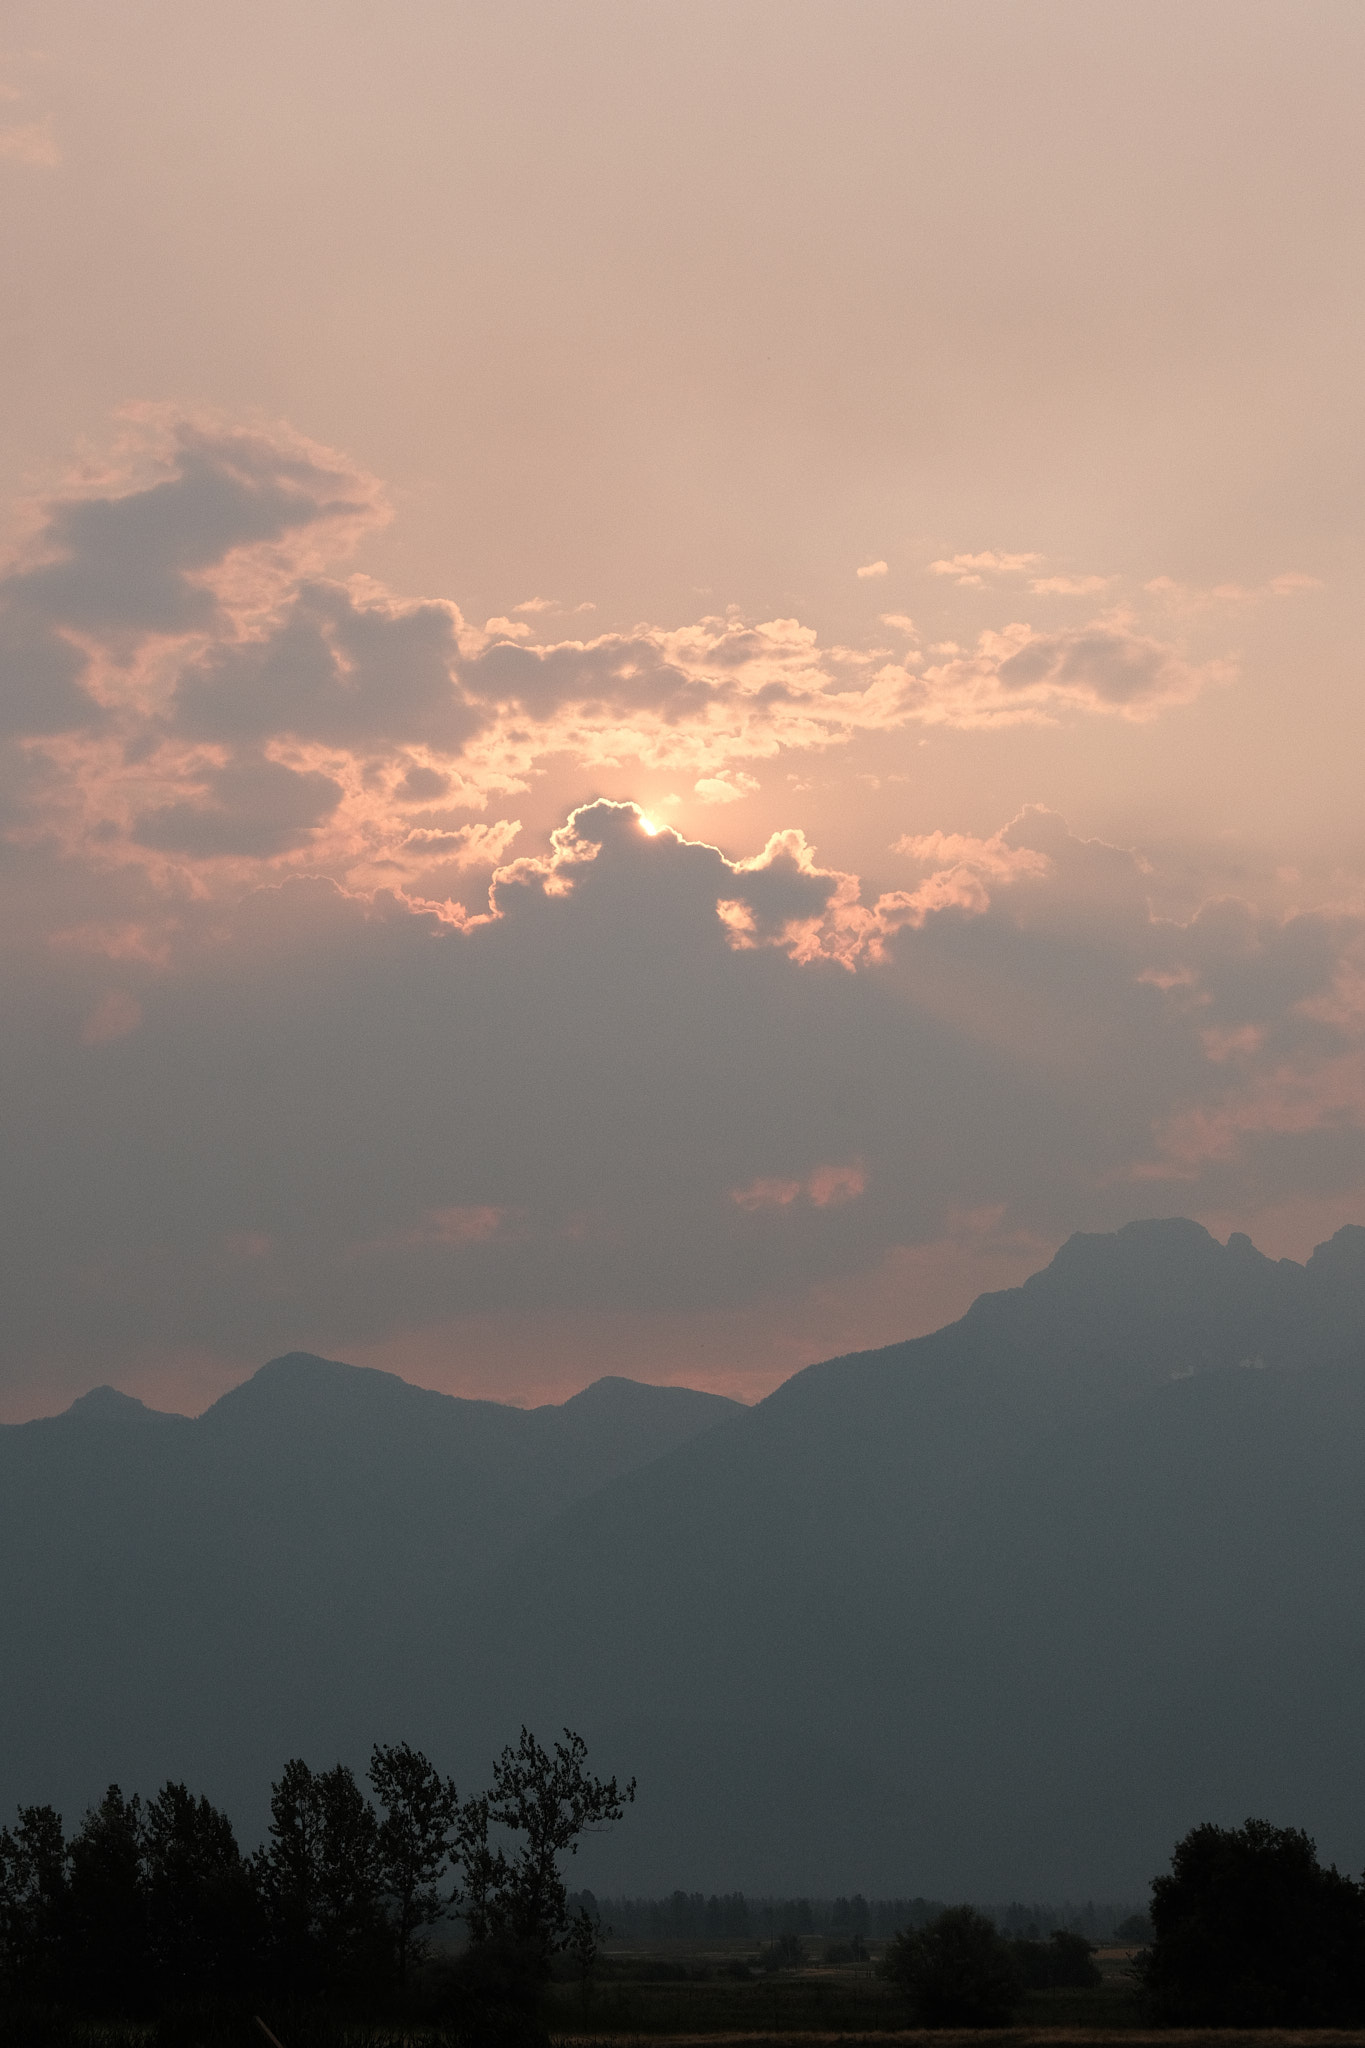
top-left (0, 0), bottom-right (1365, 1421)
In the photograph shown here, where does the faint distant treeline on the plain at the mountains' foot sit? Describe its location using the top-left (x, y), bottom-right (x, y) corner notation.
top-left (573, 1890), bottom-right (1140, 1942)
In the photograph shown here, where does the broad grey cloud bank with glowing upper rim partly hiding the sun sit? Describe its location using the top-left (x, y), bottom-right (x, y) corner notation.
top-left (0, 753), bottom-right (1365, 1409)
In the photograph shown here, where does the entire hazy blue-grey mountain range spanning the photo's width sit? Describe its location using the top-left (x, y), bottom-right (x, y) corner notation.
top-left (0, 1219), bottom-right (1365, 1896)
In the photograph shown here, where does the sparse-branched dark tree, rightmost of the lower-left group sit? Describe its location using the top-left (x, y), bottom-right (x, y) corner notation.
top-left (454, 1729), bottom-right (634, 1974)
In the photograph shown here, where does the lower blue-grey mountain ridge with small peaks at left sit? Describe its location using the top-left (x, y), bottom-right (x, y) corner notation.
top-left (0, 1352), bottom-right (741, 1829)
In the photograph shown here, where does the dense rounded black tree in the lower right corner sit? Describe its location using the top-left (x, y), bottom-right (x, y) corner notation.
top-left (1142, 1821), bottom-right (1365, 2028)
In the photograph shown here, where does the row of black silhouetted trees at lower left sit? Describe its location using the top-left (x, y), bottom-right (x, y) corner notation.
top-left (0, 1729), bottom-right (634, 2015)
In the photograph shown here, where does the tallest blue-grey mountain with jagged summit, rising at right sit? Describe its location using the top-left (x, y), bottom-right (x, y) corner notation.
top-left (458, 1221), bottom-right (1365, 1896)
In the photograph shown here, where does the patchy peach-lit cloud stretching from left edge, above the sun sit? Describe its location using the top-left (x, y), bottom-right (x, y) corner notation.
top-left (0, 408), bottom-right (1228, 903)
